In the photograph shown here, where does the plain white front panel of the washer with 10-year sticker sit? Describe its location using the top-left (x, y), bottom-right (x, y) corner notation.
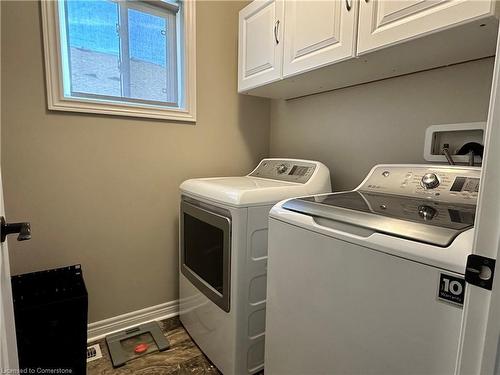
top-left (265, 219), bottom-right (462, 375)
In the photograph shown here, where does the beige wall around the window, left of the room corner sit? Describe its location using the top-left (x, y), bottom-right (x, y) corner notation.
top-left (1, 1), bottom-right (269, 321)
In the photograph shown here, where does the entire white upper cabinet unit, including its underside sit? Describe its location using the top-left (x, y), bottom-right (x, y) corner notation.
top-left (238, 0), bottom-right (500, 99)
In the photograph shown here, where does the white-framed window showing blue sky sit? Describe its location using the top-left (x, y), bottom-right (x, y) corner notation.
top-left (42, 0), bottom-right (195, 121)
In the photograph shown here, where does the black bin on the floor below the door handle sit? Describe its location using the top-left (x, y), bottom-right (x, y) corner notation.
top-left (12, 265), bottom-right (88, 375)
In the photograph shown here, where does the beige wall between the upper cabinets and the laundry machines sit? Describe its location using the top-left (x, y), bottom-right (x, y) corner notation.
top-left (270, 59), bottom-right (493, 190)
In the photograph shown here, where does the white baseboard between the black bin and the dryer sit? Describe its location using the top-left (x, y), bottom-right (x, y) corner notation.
top-left (87, 300), bottom-right (179, 342)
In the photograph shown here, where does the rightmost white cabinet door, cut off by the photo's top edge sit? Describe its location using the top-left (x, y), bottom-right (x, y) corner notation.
top-left (358, 0), bottom-right (494, 54)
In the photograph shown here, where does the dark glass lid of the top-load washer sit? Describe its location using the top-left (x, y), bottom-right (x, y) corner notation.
top-left (283, 191), bottom-right (476, 247)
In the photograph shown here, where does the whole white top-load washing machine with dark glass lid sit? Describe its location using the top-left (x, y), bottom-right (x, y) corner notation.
top-left (265, 165), bottom-right (480, 375)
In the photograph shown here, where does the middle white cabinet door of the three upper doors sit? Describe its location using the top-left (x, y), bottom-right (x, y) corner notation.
top-left (283, 0), bottom-right (358, 77)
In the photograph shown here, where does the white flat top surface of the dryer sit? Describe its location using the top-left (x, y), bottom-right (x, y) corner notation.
top-left (180, 176), bottom-right (314, 206)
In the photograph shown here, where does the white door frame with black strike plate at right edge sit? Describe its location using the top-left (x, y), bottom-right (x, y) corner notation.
top-left (456, 32), bottom-right (500, 375)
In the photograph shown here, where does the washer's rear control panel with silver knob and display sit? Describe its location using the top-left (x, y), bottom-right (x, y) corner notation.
top-left (359, 165), bottom-right (481, 204)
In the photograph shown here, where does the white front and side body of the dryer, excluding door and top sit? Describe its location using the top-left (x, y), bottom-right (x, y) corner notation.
top-left (179, 201), bottom-right (272, 374)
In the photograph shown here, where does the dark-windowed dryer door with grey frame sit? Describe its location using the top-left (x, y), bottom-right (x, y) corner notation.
top-left (180, 200), bottom-right (231, 312)
